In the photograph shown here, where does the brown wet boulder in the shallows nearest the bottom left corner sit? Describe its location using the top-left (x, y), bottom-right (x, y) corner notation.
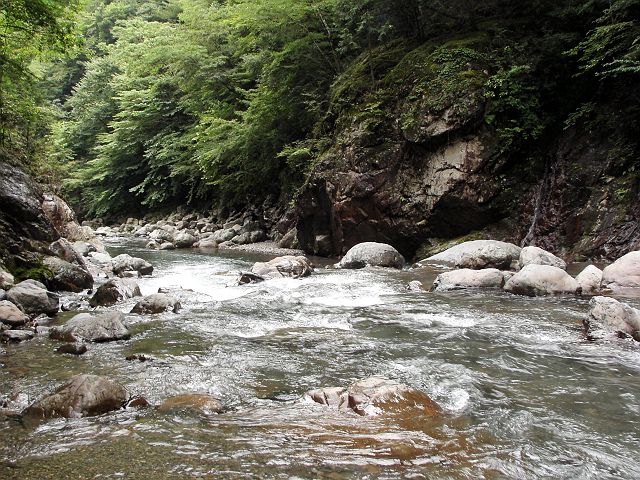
top-left (23, 375), bottom-right (131, 418)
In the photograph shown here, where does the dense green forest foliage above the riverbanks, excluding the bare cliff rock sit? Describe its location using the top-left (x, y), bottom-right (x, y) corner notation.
top-left (0, 0), bottom-right (640, 258)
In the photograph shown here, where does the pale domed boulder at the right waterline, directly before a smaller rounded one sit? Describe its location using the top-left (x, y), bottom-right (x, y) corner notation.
top-left (504, 265), bottom-right (580, 297)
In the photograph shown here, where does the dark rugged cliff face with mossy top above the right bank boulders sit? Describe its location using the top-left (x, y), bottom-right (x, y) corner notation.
top-left (296, 42), bottom-right (640, 259)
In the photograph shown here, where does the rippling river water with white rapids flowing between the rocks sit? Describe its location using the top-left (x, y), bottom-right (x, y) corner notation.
top-left (0, 241), bottom-right (640, 479)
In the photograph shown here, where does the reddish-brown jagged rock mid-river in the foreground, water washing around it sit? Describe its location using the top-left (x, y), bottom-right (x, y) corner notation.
top-left (306, 376), bottom-right (442, 418)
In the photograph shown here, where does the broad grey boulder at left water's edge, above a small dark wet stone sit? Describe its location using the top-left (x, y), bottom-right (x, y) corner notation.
top-left (49, 312), bottom-right (131, 343)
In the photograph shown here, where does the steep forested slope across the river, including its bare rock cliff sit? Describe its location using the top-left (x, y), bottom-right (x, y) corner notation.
top-left (6, 0), bottom-right (640, 256)
